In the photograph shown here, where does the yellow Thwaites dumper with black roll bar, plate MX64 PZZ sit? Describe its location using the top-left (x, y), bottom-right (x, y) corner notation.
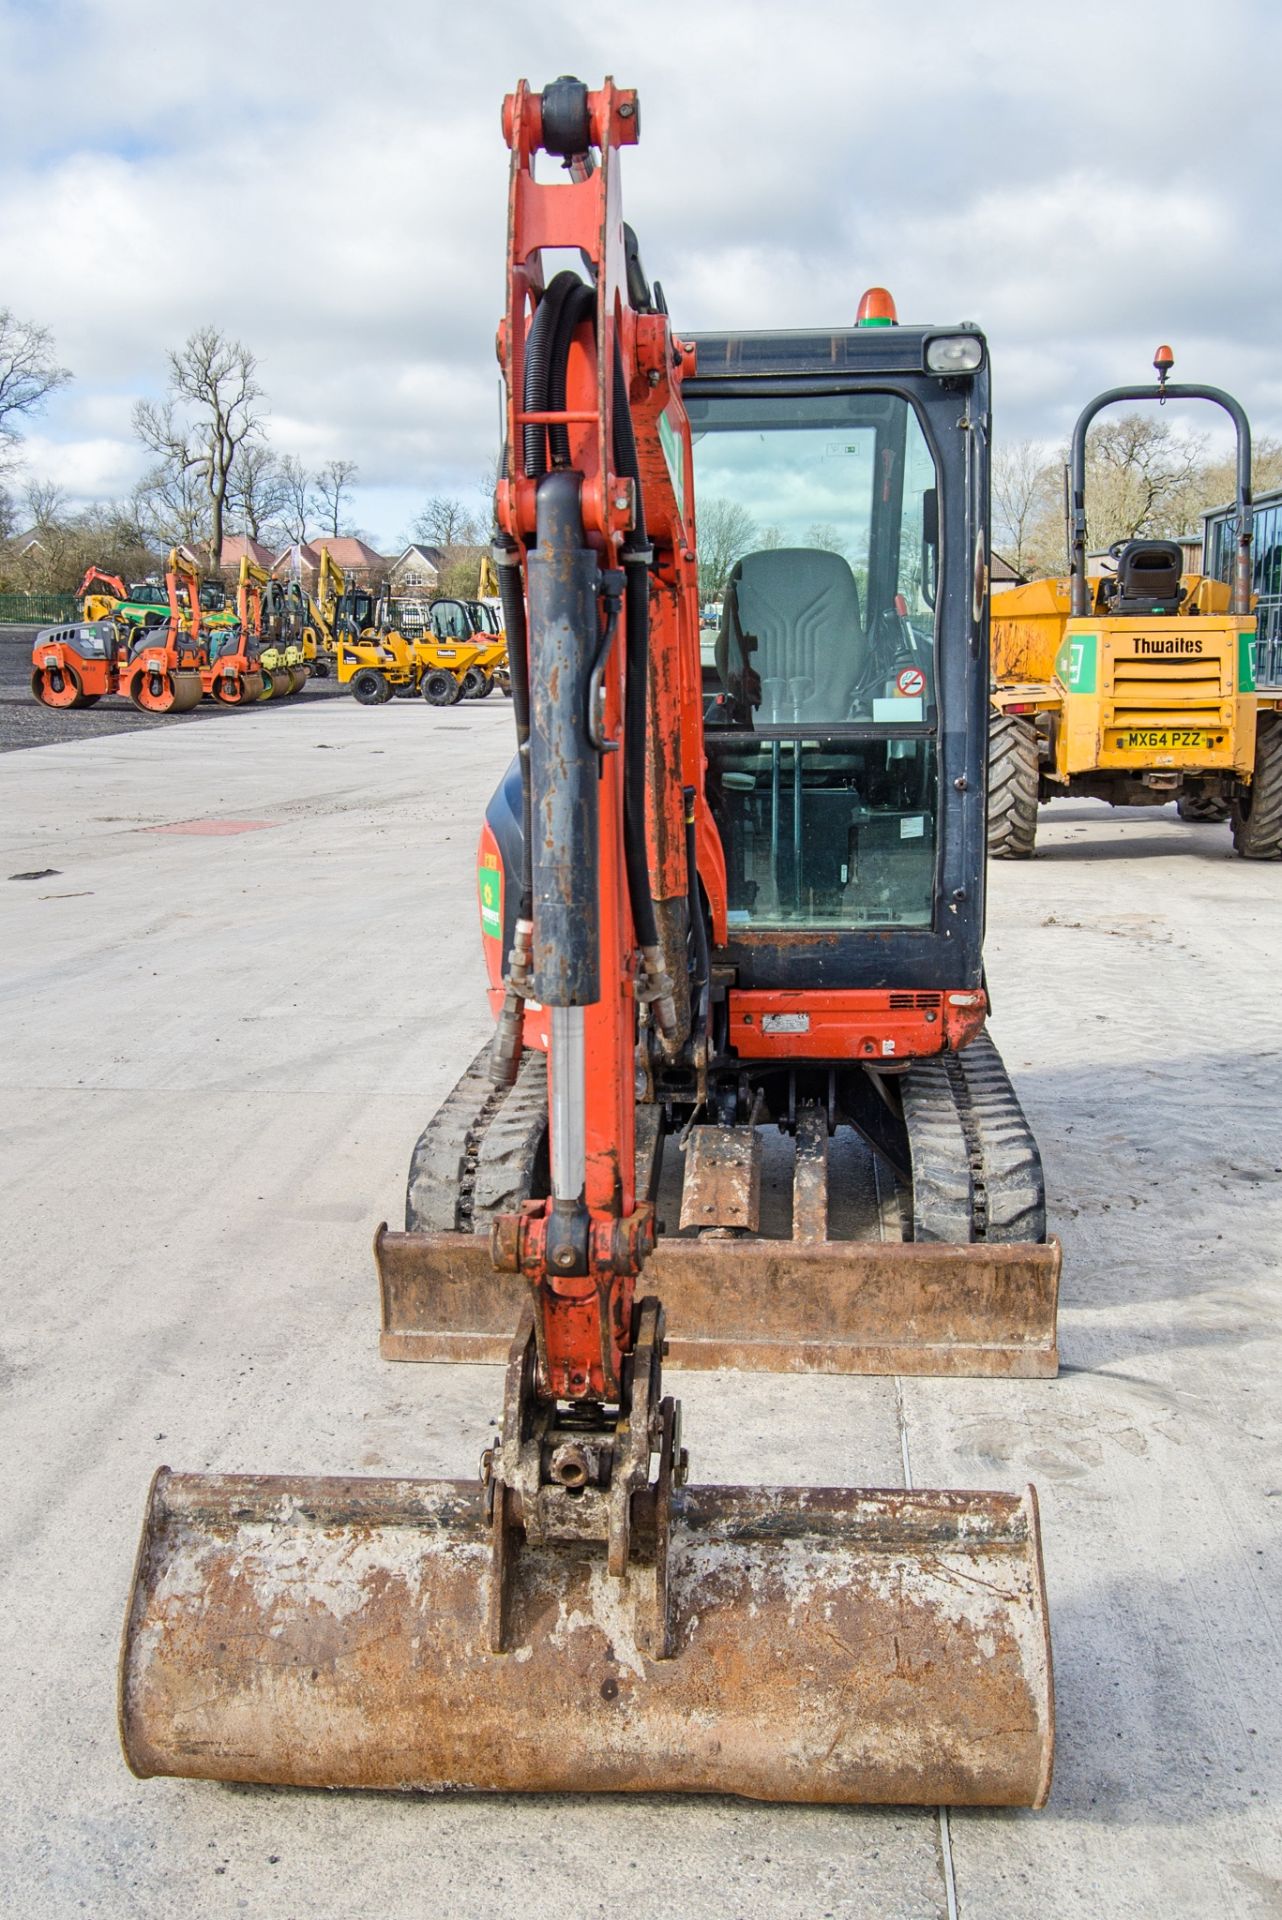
top-left (988, 346), bottom-right (1282, 860)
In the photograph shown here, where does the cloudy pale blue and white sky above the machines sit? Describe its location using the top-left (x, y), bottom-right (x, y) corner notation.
top-left (0, 0), bottom-right (1282, 545)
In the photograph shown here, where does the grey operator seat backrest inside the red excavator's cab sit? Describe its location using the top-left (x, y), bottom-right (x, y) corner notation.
top-left (716, 547), bottom-right (869, 726)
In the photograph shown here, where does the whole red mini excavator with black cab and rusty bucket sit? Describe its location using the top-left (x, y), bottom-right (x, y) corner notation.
top-left (121, 79), bottom-right (1057, 1805)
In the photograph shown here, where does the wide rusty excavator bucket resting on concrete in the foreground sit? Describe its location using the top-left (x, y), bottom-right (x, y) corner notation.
top-left (121, 1469), bottom-right (1054, 1807)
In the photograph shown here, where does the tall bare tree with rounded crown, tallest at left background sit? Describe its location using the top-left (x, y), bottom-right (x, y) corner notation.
top-left (134, 326), bottom-right (263, 570)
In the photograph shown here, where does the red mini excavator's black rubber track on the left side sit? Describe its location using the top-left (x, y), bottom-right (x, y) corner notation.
top-left (405, 1046), bottom-right (547, 1233)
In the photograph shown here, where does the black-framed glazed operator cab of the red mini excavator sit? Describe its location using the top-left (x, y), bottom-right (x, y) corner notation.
top-left (683, 347), bottom-right (988, 960)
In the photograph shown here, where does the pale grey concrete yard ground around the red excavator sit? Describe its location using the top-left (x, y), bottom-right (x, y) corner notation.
top-left (0, 699), bottom-right (1282, 1920)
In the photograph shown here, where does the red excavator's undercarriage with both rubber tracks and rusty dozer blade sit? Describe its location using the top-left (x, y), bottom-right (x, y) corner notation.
top-left (383, 1035), bottom-right (1059, 1377)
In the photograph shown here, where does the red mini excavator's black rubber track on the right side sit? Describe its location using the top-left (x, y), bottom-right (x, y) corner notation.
top-left (904, 1033), bottom-right (1046, 1244)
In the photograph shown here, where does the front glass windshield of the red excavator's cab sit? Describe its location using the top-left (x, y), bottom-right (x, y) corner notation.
top-left (687, 390), bottom-right (938, 927)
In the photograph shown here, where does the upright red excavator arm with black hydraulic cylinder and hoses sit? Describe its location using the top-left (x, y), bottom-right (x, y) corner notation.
top-left (485, 81), bottom-right (700, 1428)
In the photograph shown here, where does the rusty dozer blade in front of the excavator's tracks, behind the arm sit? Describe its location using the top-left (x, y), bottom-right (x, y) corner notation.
top-left (374, 1225), bottom-right (1059, 1379)
